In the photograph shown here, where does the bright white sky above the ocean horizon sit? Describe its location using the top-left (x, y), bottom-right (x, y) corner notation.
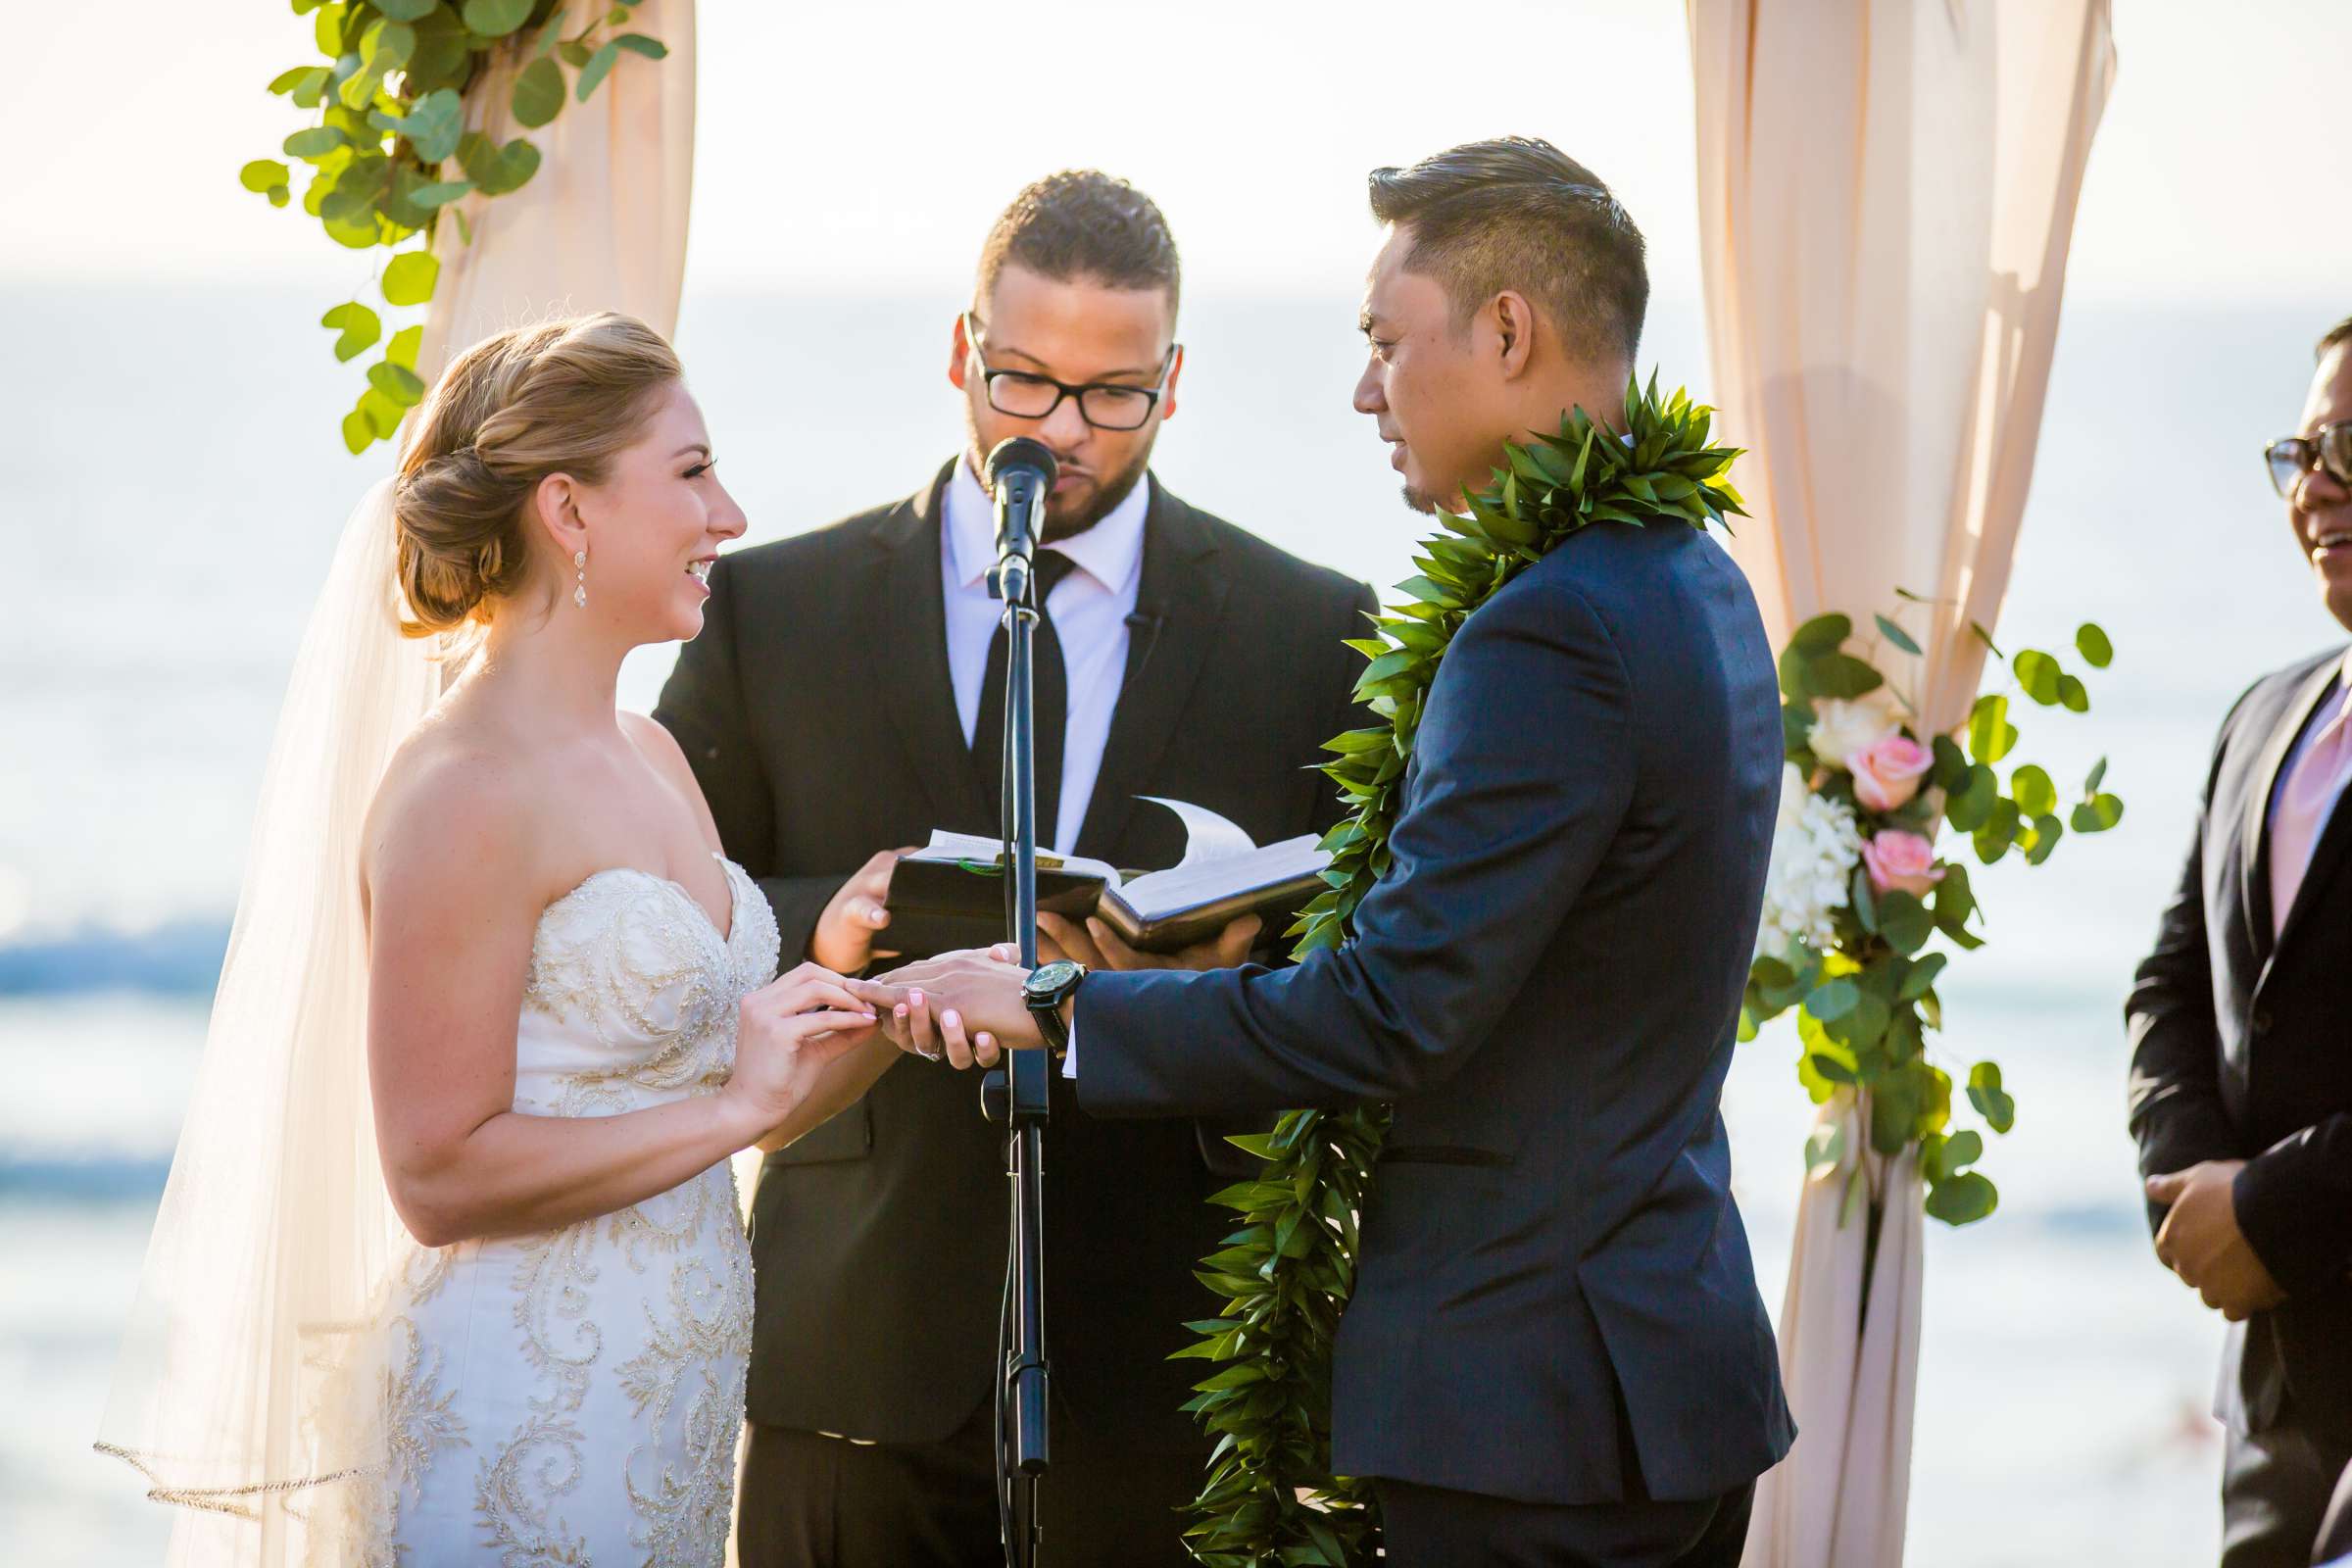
top-left (0, 0), bottom-right (2352, 303)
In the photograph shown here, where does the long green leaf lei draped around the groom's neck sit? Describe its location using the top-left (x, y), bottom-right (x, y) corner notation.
top-left (1176, 376), bottom-right (1745, 1568)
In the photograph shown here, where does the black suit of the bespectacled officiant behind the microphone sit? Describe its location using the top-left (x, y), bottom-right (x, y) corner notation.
top-left (657, 466), bottom-right (1374, 1568)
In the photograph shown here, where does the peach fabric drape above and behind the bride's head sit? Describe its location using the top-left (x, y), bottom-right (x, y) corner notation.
top-left (416, 0), bottom-right (694, 381)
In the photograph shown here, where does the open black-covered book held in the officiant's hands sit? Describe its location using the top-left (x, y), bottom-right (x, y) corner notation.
top-left (882, 795), bottom-right (1331, 955)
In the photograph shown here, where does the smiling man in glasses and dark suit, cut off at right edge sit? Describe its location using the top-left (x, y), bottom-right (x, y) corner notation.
top-left (2124, 319), bottom-right (2352, 1568)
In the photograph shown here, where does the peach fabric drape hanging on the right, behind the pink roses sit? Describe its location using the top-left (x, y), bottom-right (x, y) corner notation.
top-left (1687, 0), bottom-right (2115, 1568)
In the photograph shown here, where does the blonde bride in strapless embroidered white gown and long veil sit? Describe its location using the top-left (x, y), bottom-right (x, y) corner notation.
top-left (99, 315), bottom-right (962, 1568)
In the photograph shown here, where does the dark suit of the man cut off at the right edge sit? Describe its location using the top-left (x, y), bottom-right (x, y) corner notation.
top-left (2124, 649), bottom-right (2352, 1563)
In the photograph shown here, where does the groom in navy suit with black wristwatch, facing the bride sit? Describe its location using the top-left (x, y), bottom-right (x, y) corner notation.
top-left (860, 139), bottom-right (1792, 1568)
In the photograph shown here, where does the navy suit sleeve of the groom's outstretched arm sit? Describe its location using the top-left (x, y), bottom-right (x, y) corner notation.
top-left (1077, 583), bottom-right (1635, 1114)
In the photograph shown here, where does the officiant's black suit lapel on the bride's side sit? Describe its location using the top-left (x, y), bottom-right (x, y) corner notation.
top-left (884, 459), bottom-right (988, 830)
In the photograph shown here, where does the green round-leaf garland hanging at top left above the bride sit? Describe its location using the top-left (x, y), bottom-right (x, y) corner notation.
top-left (237, 0), bottom-right (668, 454)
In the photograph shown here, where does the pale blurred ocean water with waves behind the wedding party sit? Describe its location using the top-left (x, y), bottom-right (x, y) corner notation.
top-left (0, 284), bottom-right (2340, 1568)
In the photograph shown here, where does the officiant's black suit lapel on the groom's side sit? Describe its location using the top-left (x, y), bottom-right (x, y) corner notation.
top-left (1077, 479), bottom-right (1228, 856)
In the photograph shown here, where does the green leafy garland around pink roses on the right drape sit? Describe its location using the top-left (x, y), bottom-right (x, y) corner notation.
top-left (1740, 590), bottom-right (2124, 1234)
